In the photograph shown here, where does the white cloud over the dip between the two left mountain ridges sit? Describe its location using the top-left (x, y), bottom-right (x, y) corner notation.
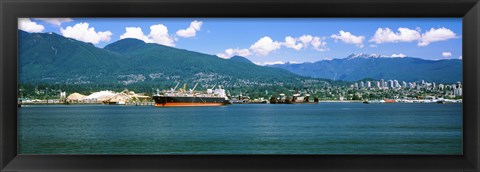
top-left (60, 23), bottom-right (112, 44)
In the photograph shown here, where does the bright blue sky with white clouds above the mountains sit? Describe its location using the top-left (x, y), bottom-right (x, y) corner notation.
top-left (19, 18), bottom-right (462, 64)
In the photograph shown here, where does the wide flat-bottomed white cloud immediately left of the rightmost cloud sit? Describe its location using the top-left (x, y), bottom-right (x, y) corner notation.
top-left (369, 27), bottom-right (421, 44)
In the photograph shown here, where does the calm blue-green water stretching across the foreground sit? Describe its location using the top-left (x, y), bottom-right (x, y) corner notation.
top-left (18, 103), bottom-right (463, 155)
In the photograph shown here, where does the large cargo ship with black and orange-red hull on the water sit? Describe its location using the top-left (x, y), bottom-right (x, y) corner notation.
top-left (153, 84), bottom-right (230, 107)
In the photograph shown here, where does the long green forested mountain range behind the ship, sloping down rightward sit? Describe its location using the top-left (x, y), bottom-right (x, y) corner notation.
top-left (19, 31), bottom-right (329, 91)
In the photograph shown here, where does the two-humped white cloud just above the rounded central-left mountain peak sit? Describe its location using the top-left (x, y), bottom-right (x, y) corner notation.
top-left (120, 24), bottom-right (175, 47)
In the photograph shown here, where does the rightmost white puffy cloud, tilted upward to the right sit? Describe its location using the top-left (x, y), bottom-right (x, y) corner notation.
top-left (418, 27), bottom-right (457, 47)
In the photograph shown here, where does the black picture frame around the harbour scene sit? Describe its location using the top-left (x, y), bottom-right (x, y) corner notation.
top-left (0, 0), bottom-right (480, 172)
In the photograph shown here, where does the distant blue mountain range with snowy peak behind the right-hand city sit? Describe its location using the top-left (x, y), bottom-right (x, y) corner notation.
top-left (270, 54), bottom-right (462, 83)
